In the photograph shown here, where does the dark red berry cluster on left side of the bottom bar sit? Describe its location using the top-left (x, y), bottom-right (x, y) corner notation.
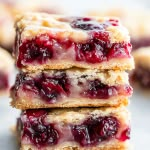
top-left (21, 110), bottom-right (59, 147)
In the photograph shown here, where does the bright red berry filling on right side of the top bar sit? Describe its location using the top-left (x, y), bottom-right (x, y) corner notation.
top-left (75, 32), bottom-right (131, 63)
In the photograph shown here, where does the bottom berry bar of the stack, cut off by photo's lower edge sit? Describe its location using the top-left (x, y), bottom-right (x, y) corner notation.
top-left (17, 108), bottom-right (130, 150)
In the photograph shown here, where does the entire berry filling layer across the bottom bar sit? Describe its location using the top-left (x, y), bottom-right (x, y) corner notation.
top-left (17, 109), bottom-right (130, 148)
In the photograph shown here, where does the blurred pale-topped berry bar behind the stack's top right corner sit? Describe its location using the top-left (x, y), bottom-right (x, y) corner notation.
top-left (124, 9), bottom-right (150, 50)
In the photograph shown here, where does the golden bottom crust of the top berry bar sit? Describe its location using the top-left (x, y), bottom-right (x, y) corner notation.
top-left (19, 57), bottom-right (134, 72)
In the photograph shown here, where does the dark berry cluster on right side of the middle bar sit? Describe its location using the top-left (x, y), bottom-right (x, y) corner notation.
top-left (82, 79), bottom-right (118, 99)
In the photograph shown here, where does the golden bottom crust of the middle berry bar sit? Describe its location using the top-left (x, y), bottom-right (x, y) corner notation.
top-left (11, 96), bottom-right (129, 110)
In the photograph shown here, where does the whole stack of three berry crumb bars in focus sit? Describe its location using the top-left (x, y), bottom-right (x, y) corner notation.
top-left (11, 13), bottom-right (134, 150)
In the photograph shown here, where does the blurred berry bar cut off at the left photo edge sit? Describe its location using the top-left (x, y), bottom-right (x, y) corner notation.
top-left (0, 47), bottom-right (14, 95)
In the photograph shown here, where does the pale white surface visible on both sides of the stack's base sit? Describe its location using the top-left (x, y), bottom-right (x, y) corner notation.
top-left (0, 90), bottom-right (150, 150)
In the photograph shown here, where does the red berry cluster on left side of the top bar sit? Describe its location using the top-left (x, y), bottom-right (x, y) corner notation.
top-left (18, 35), bottom-right (53, 66)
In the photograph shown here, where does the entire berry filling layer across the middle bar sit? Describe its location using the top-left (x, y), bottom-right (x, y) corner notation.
top-left (12, 70), bottom-right (133, 104)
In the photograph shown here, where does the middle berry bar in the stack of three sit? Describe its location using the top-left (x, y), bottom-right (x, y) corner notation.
top-left (11, 69), bottom-right (132, 109)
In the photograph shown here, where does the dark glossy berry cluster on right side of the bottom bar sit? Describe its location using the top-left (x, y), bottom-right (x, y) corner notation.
top-left (72, 116), bottom-right (119, 146)
